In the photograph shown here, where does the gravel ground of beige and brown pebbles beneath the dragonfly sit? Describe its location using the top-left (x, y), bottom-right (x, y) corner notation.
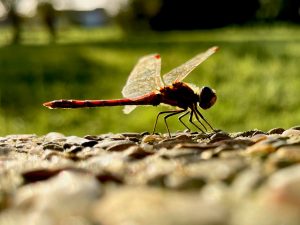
top-left (0, 126), bottom-right (300, 225)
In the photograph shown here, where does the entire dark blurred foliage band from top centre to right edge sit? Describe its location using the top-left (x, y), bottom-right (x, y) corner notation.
top-left (117, 0), bottom-right (300, 31)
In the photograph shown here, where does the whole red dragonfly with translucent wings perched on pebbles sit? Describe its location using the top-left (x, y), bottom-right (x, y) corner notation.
top-left (43, 46), bottom-right (218, 137)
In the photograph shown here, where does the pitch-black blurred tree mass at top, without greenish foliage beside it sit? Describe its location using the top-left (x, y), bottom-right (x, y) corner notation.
top-left (150, 0), bottom-right (259, 30)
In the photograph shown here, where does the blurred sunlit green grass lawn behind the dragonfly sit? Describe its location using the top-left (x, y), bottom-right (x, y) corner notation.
top-left (0, 25), bottom-right (300, 135)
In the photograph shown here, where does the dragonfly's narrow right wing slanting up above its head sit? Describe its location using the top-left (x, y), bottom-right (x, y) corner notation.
top-left (163, 47), bottom-right (218, 85)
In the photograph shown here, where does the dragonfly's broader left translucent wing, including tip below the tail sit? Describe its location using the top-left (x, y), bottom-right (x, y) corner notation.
top-left (122, 54), bottom-right (163, 113)
